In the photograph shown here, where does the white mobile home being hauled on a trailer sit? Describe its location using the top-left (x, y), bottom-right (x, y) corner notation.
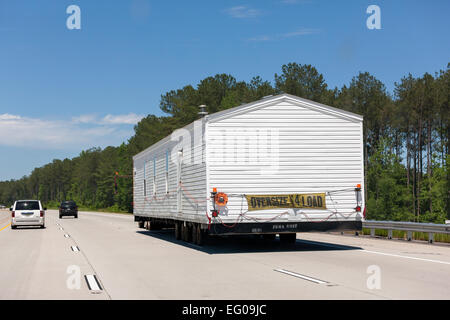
top-left (133, 94), bottom-right (365, 243)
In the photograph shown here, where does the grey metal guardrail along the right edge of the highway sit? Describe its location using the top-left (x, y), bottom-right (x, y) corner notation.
top-left (363, 220), bottom-right (450, 243)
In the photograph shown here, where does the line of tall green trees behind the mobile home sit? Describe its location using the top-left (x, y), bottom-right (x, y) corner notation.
top-left (0, 63), bottom-right (450, 223)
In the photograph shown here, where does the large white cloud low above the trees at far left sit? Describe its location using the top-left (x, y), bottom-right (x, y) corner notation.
top-left (0, 113), bottom-right (142, 150)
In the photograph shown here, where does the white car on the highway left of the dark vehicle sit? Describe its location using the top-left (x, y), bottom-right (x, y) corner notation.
top-left (9, 200), bottom-right (47, 229)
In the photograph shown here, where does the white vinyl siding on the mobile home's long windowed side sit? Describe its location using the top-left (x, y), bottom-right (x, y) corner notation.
top-left (133, 119), bottom-right (206, 221)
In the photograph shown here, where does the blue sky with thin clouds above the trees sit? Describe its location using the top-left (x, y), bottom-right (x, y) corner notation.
top-left (0, 0), bottom-right (450, 180)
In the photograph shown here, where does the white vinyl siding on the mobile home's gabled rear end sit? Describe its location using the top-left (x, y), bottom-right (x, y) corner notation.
top-left (207, 101), bottom-right (364, 222)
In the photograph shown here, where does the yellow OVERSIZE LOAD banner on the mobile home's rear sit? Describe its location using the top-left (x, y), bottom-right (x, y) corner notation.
top-left (245, 193), bottom-right (327, 211)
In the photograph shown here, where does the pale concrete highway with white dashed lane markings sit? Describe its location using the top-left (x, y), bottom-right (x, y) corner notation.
top-left (0, 210), bottom-right (450, 300)
